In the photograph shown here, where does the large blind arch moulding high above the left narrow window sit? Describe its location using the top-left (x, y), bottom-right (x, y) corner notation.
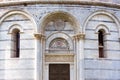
top-left (0, 10), bottom-right (37, 32)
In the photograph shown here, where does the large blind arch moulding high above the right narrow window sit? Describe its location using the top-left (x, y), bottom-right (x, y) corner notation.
top-left (82, 10), bottom-right (120, 36)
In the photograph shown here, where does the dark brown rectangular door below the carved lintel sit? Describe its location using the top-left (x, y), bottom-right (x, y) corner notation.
top-left (49, 64), bottom-right (70, 80)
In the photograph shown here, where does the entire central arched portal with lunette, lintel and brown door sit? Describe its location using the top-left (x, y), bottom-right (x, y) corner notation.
top-left (41, 12), bottom-right (79, 80)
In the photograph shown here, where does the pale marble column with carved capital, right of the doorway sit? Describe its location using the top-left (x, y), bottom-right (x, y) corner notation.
top-left (74, 33), bottom-right (85, 80)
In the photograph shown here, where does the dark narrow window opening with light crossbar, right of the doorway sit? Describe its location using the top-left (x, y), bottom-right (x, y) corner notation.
top-left (98, 30), bottom-right (105, 58)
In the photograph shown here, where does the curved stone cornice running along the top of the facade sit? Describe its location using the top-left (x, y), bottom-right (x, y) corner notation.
top-left (0, 0), bottom-right (120, 8)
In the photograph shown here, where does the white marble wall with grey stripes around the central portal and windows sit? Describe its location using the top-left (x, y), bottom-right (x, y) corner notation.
top-left (0, 4), bottom-right (120, 80)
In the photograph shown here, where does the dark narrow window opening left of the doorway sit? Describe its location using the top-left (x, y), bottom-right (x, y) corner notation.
top-left (12, 29), bottom-right (20, 58)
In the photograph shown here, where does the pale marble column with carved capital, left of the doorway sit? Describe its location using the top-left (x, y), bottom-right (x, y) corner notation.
top-left (34, 33), bottom-right (45, 80)
